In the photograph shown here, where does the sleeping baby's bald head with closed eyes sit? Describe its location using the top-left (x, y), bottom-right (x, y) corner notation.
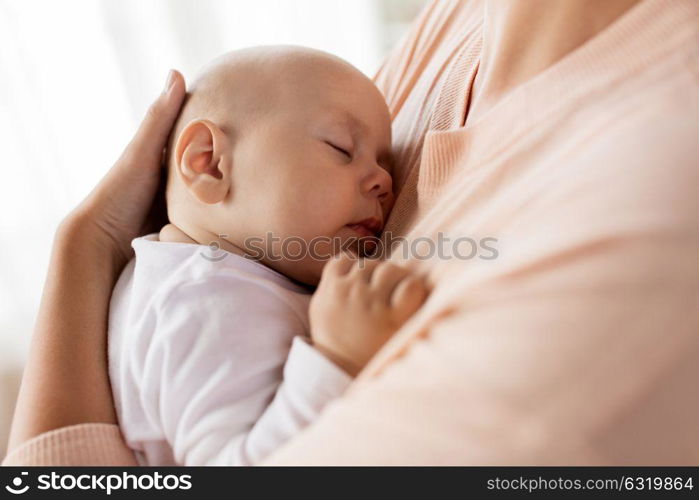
top-left (167, 46), bottom-right (393, 284)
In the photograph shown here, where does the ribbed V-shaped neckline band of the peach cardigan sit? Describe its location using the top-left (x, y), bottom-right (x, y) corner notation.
top-left (426, 0), bottom-right (699, 170)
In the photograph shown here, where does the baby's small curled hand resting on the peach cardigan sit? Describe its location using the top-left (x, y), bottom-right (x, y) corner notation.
top-left (310, 254), bottom-right (428, 376)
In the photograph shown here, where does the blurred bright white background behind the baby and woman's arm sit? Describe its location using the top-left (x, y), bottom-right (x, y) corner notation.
top-left (0, 0), bottom-right (425, 457)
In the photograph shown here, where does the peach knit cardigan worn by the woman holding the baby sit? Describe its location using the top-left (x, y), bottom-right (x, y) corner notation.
top-left (5, 0), bottom-right (699, 465)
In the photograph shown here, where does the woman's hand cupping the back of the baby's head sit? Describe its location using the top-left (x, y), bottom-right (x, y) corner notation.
top-left (68, 70), bottom-right (185, 268)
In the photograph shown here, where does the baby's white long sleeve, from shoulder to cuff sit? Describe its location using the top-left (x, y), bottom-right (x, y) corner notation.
top-left (140, 280), bottom-right (351, 465)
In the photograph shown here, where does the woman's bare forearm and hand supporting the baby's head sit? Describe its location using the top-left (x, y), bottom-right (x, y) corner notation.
top-left (8, 71), bottom-right (185, 451)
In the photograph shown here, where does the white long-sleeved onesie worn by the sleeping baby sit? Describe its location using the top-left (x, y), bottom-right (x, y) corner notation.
top-left (109, 234), bottom-right (351, 465)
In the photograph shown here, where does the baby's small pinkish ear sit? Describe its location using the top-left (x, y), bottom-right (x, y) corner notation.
top-left (175, 120), bottom-right (232, 204)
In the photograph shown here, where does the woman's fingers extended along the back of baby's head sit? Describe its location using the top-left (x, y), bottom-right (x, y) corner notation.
top-left (122, 70), bottom-right (186, 168)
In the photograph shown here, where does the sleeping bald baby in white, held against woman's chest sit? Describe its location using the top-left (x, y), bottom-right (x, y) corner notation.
top-left (109, 47), bottom-right (426, 465)
